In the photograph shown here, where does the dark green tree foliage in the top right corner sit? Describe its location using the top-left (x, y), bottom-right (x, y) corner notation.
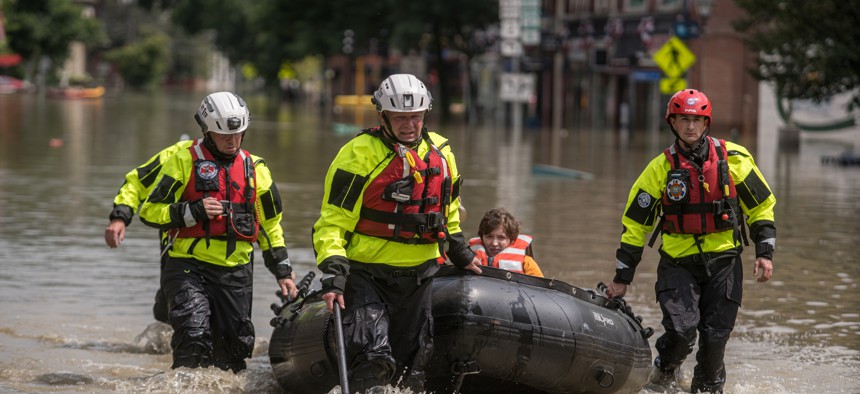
top-left (734, 0), bottom-right (860, 110)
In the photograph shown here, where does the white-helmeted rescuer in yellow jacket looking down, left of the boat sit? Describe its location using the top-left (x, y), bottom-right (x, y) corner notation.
top-left (140, 92), bottom-right (297, 372)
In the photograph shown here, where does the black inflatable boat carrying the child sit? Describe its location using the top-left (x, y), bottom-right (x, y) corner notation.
top-left (269, 266), bottom-right (653, 393)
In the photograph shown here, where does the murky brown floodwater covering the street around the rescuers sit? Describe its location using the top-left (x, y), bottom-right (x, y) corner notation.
top-left (0, 92), bottom-right (860, 393)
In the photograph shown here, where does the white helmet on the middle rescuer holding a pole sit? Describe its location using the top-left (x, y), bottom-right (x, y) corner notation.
top-left (372, 74), bottom-right (433, 112)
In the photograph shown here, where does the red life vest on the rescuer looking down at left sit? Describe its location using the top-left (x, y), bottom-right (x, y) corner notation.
top-left (177, 144), bottom-right (259, 243)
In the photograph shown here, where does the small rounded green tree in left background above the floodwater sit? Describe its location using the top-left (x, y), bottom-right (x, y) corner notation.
top-left (105, 33), bottom-right (170, 88)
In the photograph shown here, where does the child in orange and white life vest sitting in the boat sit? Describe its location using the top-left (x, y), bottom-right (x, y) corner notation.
top-left (469, 208), bottom-right (543, 278)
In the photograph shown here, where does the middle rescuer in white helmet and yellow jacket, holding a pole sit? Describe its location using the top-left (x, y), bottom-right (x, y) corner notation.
top-left (313, 74), bottom-right (481, 392)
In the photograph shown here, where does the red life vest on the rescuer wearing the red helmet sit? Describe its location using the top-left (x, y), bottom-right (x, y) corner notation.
top-left (662, 137), bottom-right (741, 234)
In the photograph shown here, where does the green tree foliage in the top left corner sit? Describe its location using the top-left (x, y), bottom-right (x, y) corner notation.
top-left (3, 0), bottom-right (105, 82)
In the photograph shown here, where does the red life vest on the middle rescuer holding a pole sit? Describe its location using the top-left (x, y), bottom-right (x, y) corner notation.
top-left (355, 129), bottom-right (453, 244)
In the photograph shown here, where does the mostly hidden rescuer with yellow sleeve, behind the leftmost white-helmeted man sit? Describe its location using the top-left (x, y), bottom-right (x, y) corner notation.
top-left (105, 136), bottom-right (198, 323)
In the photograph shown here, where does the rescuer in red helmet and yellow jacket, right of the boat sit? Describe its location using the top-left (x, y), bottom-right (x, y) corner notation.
top-left (607, 89), bottom-right (776, 393)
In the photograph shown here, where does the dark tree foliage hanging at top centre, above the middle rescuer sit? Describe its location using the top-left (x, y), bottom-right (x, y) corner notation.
top-left (149, 0), bottom-right (386, 85)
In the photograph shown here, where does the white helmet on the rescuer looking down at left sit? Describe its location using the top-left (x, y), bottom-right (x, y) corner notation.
top-left (194, 92), bottom-right (251, 134)
